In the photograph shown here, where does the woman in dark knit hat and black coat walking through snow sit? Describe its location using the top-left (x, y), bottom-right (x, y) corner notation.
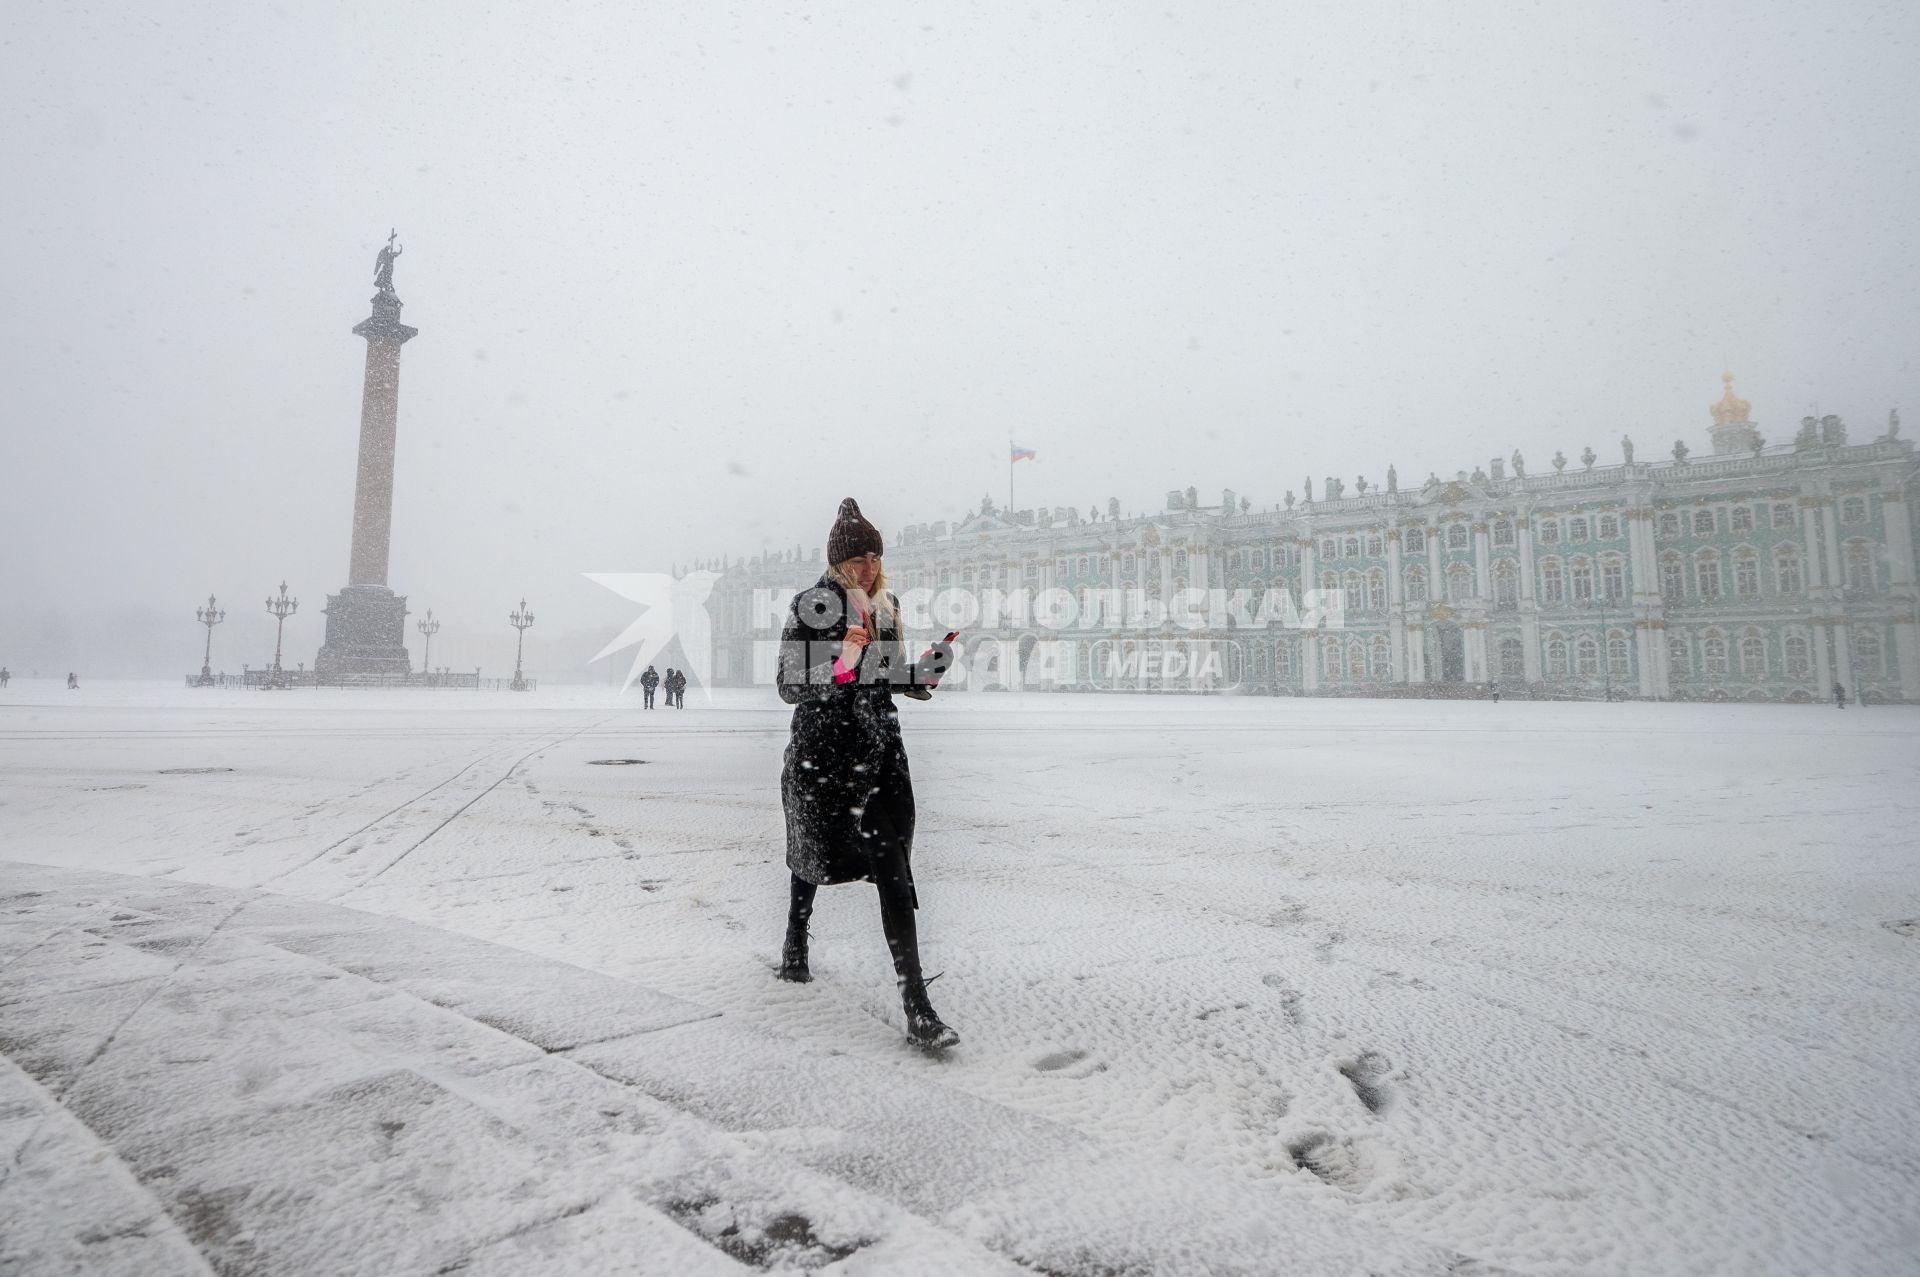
top-left (778, 497), bottom-right (960, 1047)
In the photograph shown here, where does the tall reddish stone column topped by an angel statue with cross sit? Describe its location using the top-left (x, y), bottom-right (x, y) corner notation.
top-left (313, 234), bottom-right (419, 678)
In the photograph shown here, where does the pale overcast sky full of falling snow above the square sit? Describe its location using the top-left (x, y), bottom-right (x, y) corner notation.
top-left (0, 0), bottom-right (1920, 668)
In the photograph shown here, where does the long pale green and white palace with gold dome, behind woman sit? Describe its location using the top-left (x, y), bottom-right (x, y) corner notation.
top-left (708, 376), bottom-right (1920, 703)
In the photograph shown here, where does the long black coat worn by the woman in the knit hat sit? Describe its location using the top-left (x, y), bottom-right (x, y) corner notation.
top-left (778, 576), bottom-right (914, 885)
